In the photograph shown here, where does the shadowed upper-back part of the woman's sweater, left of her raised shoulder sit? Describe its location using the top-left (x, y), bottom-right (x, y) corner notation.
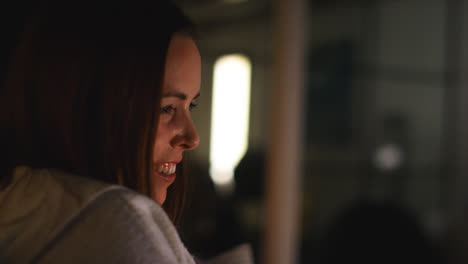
top-left (0, 166), bottom-right (117, 263)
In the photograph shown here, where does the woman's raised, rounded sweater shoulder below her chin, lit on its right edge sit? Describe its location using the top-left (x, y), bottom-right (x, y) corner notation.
top-left (36, 188), bottom-right (193, 263)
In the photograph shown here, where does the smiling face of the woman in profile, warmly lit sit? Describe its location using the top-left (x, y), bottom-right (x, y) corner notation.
top-left (152, 34), bottom-right (201, 205)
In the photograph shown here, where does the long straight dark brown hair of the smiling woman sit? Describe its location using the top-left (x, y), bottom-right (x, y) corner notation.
top-left (0, 0), bottom-right (193, 222)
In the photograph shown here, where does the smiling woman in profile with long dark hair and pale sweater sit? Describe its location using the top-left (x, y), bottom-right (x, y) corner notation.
top-left (0, 1), bottom-right (200, 263)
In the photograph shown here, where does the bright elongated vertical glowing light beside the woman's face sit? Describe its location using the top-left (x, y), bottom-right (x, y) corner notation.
top-left (210, 54), bottom-right (252, 190)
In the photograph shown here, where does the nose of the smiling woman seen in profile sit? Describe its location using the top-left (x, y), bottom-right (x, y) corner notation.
top-left (171, 114), bottom-right (200, 150)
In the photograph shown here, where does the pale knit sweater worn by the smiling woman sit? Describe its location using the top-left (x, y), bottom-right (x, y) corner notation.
top-left (0, 167), bottom-right (194, 263)
